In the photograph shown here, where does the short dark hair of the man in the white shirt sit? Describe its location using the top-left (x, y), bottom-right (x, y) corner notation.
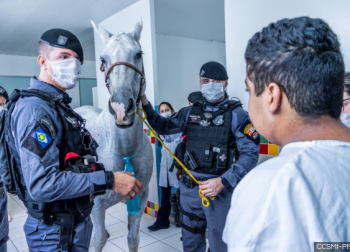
top-left (245, 17), bottom-right (344, 119)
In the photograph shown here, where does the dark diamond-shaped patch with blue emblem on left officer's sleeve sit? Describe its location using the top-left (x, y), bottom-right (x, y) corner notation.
top-left (22, 122), bottom-right (53, 158)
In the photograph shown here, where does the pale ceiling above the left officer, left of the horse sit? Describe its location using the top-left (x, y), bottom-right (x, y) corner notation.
top-left (0, 0), bottom-right (138, 60)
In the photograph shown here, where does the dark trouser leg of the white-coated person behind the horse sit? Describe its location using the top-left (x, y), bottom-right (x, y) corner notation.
top-left (155, 185), bottom-right (171, 228)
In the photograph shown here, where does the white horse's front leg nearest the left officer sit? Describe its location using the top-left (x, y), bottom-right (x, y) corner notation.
top-left (92, 196), bottom-right (108, 252)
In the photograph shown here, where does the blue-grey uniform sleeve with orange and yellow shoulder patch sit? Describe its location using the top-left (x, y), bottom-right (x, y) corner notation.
top-left (221, 107), bottom-right (260, 187)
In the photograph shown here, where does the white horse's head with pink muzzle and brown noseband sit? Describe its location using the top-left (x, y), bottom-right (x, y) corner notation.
top-left (91, 20), bottom-right (145, 128)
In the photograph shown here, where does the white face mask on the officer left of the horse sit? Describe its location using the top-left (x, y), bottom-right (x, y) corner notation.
top-left (47, 58), bottom-right (81, 89)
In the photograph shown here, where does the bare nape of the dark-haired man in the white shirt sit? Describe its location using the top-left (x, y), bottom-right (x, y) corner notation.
top-left (275, 116), bottom-right (350, 146)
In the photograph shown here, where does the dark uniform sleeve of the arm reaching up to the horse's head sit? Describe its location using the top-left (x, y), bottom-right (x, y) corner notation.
top-left (143, 102), bottom-right (192, 135)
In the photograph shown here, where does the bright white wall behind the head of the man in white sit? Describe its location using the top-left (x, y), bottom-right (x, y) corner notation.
top-left (225, 0), bottom-right (350, 109)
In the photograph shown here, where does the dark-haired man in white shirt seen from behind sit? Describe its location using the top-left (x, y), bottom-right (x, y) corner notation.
top-left (223, 17), bottom-right (350, 252)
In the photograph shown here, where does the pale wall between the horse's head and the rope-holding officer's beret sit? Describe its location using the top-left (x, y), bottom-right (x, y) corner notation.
top-left (155, 34), bottom-right (226, 111)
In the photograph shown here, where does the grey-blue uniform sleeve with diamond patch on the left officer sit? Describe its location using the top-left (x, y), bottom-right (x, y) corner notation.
top-left (11, 106), bottom-right (108, 202)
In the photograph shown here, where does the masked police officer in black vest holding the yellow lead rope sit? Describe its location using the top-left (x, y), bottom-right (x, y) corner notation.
top-left (142, 62), bottom-right (260, 252)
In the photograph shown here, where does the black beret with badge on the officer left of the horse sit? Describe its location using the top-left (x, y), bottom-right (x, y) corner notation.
top-left (40, 29), bottom-right (84, 64)
